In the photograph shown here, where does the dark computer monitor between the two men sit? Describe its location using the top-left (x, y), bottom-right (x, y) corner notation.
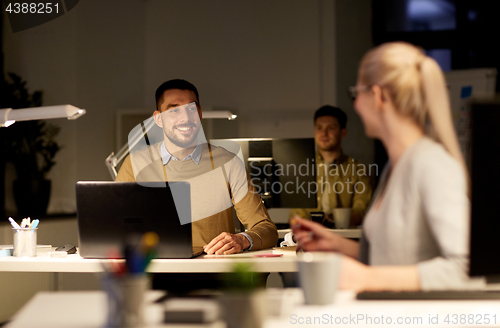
top-left (210, 138), bottom-right (318, 208)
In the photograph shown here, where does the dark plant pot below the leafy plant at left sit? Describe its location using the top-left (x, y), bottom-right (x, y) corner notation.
top-left (13, 179), bottom-right (51, 216)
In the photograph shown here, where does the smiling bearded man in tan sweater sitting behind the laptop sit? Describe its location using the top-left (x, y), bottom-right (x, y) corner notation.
top-left (116, 79), bottom-right (278, 255)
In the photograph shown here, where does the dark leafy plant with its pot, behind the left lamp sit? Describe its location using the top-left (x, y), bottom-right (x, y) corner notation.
top-left (0, 73), bottom-right (60, 215)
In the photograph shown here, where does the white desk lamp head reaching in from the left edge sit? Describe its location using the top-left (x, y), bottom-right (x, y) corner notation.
top-left (0, 105), bottom-right (86, 127)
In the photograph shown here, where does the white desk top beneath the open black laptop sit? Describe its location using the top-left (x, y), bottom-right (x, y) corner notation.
top-left (0, 248), bottom-right (297, 272)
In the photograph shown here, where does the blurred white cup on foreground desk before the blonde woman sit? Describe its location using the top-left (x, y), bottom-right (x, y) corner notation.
top-left (297, 252), bottom-right (341, 305)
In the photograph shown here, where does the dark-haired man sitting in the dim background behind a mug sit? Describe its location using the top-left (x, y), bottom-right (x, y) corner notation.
top-left (290, 105), bottom-right (372, 227)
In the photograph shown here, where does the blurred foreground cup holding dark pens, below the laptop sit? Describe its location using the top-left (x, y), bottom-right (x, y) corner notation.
top-left (103, 274), bottom-right (149, 327)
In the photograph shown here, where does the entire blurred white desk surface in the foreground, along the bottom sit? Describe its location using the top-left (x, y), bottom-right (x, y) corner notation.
top-left (5, 291), bottom-right (500, 328)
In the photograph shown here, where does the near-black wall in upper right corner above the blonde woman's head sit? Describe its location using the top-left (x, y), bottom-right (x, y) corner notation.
top-left (372, 0), bottom-right (500, 91)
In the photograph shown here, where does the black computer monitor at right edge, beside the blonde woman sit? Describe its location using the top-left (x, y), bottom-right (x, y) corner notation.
top-left (470, 100), bottom-right (500, 281)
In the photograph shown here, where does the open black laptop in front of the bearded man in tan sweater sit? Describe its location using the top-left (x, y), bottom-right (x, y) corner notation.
top-left (76, 181), bottom-right (202, 259)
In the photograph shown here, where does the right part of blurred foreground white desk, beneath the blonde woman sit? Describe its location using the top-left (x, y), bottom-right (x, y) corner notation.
top-left (264, 291), bottom-right (500, 328)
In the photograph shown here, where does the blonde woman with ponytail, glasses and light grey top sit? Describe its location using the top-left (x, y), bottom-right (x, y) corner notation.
top-left (293, 42), bottom-right (484, 291)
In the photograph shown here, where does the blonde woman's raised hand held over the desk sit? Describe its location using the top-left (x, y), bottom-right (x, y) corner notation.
top-left (291, 217), bottom-right (342, 252)
